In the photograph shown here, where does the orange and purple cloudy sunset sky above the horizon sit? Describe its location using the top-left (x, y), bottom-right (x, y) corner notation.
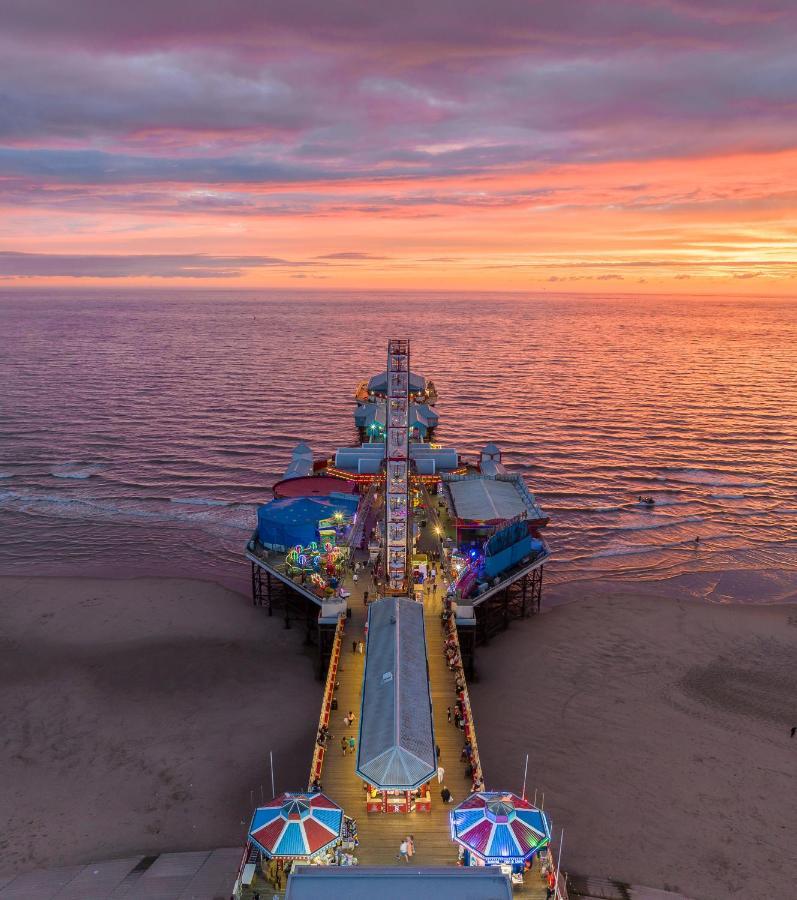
top-left (0, 0), bottom-right (797, 296)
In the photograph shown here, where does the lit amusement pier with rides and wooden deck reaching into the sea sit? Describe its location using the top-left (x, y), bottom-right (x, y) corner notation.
top-left (235, 341), bottom-right (567, 900)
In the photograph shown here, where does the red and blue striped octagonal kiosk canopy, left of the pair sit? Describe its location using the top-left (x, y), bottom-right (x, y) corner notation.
top-left (249, 794), bottom-right (343, 859)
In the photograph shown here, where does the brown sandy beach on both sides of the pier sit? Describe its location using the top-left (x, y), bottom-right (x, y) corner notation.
top-left (0, 578), bottom-right (797, 900)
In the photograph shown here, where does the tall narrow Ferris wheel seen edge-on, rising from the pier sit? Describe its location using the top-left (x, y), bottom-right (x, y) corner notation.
top-left (385, 340), bottom-right (410, 595)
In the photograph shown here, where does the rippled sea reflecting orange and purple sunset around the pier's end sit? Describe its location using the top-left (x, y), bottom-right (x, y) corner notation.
top-left (0, 291), bottom-right (797, 599)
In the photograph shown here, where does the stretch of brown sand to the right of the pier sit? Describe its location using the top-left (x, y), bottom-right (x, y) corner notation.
top-left (471, 583), bottom-right (797, 900)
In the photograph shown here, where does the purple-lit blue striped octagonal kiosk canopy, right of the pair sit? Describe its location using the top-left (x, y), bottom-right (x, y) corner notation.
top-left (451, 791), bottom-right (551, 865)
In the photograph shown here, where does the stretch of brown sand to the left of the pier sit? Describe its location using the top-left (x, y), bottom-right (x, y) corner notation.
top-left (0, 578), bottom-right (322, 875)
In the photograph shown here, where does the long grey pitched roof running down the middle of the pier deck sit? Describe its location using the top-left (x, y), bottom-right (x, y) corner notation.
top-left (357, 597), bottom-right (437, 790)
